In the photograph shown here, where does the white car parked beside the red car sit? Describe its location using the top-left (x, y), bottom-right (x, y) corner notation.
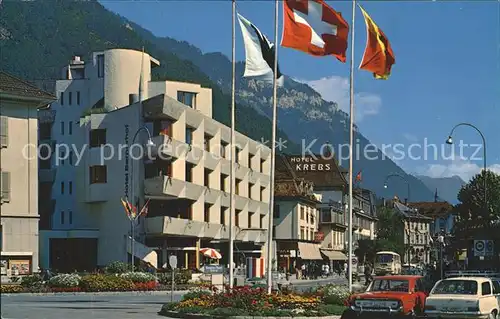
top-left (425, 277), bottom-right (500, 319)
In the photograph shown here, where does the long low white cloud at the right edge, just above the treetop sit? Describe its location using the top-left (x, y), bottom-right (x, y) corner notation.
top-left (417, 158), bottom-right (500, 182)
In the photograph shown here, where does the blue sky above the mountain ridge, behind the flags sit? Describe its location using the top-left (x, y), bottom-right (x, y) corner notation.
top-left (100, 0), bottom-right (500, 181)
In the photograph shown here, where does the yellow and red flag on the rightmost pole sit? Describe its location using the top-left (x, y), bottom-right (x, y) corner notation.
top-left (359, 6), bottom-right (396, 80)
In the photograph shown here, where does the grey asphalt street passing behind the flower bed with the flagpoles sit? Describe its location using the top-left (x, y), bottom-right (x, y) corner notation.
top-left (1, 277), bottom-right (345, 319)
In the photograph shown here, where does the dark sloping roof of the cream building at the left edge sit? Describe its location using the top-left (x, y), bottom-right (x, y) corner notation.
top-left (0, 71), bottom-right (57, 101)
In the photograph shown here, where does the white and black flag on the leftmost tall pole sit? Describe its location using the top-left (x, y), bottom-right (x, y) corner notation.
top-left (238, 13), bottom-right (284, 86)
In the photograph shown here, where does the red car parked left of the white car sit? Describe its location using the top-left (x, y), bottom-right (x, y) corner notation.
top-left (342, 275), bottom-right (428, 319)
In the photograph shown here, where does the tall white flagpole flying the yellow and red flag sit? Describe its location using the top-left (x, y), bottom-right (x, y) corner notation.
top-left (347, 0), bottom-right (356, 292)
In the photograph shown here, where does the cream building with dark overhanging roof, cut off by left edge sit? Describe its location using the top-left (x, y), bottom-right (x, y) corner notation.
top-left (0, 71), bottom-right (55, 276)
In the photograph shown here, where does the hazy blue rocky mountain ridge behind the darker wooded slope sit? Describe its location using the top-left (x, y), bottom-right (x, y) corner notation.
top-left (0, 0), bottom-right (434, 201)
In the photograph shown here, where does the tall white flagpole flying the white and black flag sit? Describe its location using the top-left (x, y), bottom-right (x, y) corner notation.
top-left (229, 0), bottom-right (236, 289)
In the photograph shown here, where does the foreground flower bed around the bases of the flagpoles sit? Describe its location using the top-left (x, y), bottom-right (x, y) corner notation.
top-left (159, 287), bottom-right (345, 318)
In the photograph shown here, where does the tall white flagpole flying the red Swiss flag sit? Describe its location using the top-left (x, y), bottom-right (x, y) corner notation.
top-left (267, 0), bottom-right (279, 294)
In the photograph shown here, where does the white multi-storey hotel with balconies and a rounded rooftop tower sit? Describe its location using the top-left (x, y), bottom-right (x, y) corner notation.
top-left (39, 49), bottom-right (271, 271)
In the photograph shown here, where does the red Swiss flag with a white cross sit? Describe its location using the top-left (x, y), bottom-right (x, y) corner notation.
top-left (281, 0), bottom-right (349, 62)
